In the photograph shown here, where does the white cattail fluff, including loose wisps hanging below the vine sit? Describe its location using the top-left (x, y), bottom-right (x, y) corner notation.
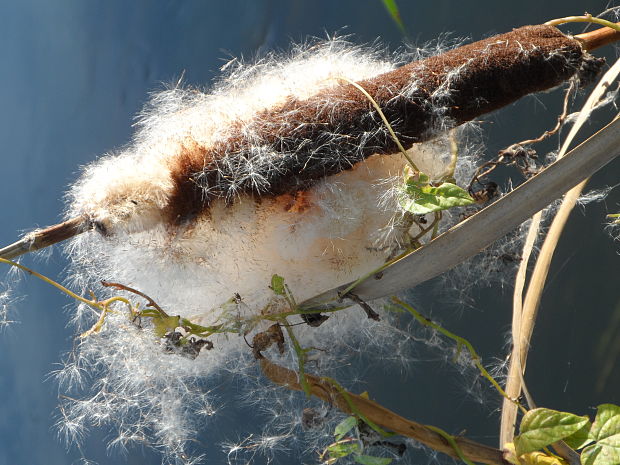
top-left (58, 40), bottom-right (462, 463)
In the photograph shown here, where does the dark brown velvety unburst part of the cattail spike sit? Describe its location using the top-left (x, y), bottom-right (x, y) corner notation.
top-left (169, 25), bottom-right (588, 223)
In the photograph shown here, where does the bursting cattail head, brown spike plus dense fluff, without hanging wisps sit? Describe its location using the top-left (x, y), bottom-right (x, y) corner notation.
top-left (69, 26), bottom-right (585, 322)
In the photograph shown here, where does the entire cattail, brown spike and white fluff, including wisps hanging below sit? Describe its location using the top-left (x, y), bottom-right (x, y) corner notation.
top-left (61, 26), bottom-right (600, 457)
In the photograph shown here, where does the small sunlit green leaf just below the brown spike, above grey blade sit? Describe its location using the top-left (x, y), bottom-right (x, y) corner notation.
top-left (400, 177), bottom-right (474, 215)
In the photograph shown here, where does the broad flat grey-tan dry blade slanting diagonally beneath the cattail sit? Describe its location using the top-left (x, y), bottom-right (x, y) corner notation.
top-left (299, 120), bottom-right (620, 311)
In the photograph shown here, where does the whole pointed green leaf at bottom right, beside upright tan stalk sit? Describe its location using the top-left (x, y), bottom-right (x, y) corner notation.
top-left (514, 408), bottom-right (590, 456)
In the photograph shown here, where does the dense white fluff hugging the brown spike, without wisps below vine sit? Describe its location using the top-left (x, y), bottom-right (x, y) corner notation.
top-left (68, 41), bottom-right (450, 324)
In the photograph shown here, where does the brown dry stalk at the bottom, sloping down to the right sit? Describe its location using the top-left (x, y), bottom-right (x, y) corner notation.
top-left (260, 358), bottom-right (508, 465)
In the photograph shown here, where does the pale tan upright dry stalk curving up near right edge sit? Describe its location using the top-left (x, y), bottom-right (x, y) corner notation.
top-left (500, 56), bottom-right (620, 446)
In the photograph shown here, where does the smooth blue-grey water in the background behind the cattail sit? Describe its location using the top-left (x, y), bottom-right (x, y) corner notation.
top-left (0, 0), bottom-right (620, 465)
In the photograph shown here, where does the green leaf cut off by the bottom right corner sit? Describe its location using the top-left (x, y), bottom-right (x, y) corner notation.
top-left (581, 404), bottom-right (620, 465)
